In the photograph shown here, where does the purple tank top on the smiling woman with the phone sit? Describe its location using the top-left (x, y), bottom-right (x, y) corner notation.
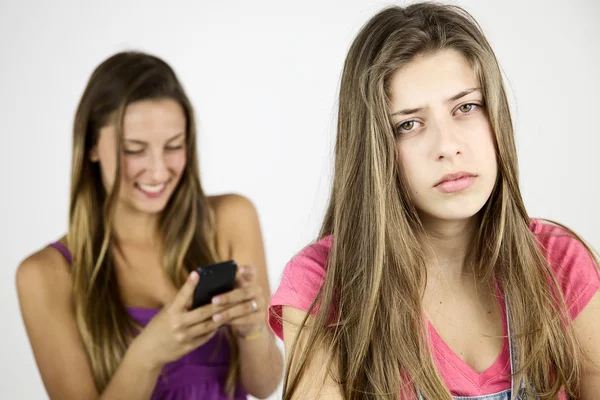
top-left (50, 242), bottom-right (247, 400)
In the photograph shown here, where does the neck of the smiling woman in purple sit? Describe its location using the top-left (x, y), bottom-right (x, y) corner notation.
top-left (113, 204), bottom-right (160, 246)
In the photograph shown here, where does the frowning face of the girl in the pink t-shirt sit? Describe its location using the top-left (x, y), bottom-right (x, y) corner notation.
top-left (390, 50), bottom-right (498, 222)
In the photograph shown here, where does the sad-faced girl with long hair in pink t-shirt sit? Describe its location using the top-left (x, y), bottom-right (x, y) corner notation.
top-left (270, 3), bottom-right (600, 400)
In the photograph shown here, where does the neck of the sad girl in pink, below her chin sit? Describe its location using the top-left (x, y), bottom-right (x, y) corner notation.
top-left (421, 212), bottom-right (477, 281)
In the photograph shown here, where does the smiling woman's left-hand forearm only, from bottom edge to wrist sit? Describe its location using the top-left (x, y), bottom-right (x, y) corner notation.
top-left (100, 342), bottom-right (161, 400)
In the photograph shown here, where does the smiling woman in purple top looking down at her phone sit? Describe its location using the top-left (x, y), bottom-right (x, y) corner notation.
top-left (17, 52), bottom-right (282, 400)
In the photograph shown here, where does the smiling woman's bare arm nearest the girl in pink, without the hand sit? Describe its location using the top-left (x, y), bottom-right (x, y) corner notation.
top-left (213, 195), bottom-right (283, 398)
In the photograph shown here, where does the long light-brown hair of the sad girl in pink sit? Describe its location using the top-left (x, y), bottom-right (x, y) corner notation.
top-left (284, 3), bottom-right (589, 400)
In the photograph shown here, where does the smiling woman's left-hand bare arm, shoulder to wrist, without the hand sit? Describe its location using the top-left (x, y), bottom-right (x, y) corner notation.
top-left (16, 249), bottom-right (159, 400)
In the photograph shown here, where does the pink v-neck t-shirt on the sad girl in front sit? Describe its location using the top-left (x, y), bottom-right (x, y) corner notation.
top-left (269, 219), bottom-right (600, 399)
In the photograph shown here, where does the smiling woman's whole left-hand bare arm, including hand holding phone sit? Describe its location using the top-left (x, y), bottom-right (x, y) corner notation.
top-left (17, 248), bottom-right (223, 400)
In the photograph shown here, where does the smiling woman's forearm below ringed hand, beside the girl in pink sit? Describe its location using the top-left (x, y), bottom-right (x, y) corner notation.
top-left (237, 326), bottom-right (283, 398)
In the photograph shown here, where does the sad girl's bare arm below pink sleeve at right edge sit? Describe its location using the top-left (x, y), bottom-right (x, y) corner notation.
top-left (573, 292), bottom-right (600, 400)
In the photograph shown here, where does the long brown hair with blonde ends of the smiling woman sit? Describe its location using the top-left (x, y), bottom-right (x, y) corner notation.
top-left (67, 52), bottom-right (238, 394)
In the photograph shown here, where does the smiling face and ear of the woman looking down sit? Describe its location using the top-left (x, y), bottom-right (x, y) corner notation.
top-left (90, 99), bottom-right (187, 214)
